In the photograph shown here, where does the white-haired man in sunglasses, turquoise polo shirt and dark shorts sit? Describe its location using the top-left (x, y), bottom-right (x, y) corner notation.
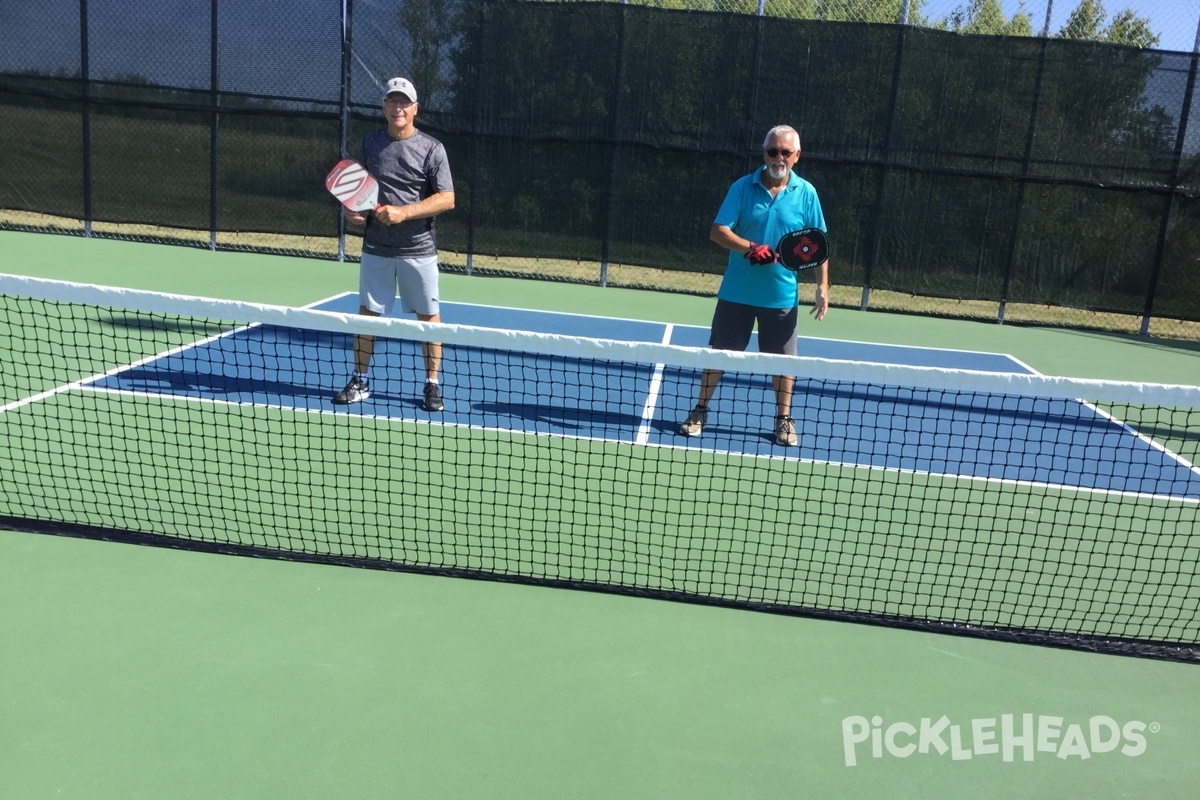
top-left (679, 125), bottom-right (829, 446)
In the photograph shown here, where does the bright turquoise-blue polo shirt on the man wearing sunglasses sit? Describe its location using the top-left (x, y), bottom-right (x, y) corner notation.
top-left (713, 166), bottom-right (826, 308)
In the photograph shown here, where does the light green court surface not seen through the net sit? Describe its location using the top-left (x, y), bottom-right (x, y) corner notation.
top-left (0, 231), bottom-right (1200, 800)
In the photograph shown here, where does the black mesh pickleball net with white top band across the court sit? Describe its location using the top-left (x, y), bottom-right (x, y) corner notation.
top-left (7, 276), bottom-right (1200, 661)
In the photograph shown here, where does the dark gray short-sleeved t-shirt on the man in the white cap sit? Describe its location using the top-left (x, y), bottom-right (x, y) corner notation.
top-left (361, 128), bottom-right (454, 258)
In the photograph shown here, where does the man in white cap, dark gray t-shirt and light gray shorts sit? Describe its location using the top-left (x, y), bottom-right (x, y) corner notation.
top-left (334, 78), bottom-right (454, 411)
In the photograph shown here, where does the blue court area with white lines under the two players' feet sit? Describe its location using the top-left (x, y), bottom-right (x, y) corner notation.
top-left (89, 294), bottom-right (1200, 501)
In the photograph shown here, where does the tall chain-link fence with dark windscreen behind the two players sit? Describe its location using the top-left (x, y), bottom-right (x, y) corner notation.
top-left (0, 0), bottom-right (1200, 338)
